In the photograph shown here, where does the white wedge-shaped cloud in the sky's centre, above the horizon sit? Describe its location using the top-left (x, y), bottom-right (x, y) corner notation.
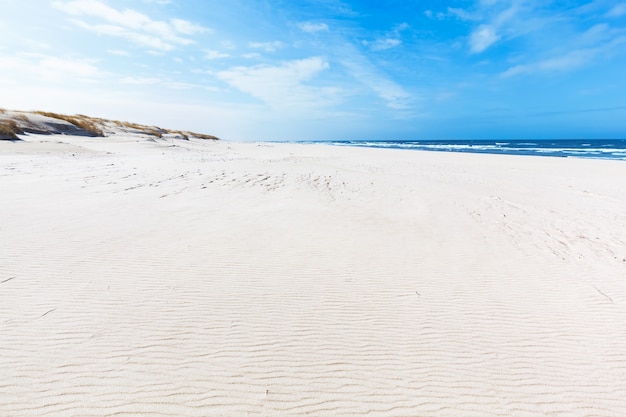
top-left (216, 57), bottom-right (336, 109)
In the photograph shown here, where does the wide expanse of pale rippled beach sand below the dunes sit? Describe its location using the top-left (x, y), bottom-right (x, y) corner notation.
top-left (0, 136), bottom-right (626, 417)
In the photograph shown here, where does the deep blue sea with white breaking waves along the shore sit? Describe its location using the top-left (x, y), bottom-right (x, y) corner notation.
top-left (308, 139), bottom-right (626, 160)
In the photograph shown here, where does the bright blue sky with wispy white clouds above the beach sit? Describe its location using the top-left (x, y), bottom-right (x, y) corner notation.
top-left (0, 0), bottom-right (626, 140)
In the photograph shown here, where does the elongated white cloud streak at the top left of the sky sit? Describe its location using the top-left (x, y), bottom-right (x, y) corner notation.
top-left (52, 0), bottom-right (209, 51)
